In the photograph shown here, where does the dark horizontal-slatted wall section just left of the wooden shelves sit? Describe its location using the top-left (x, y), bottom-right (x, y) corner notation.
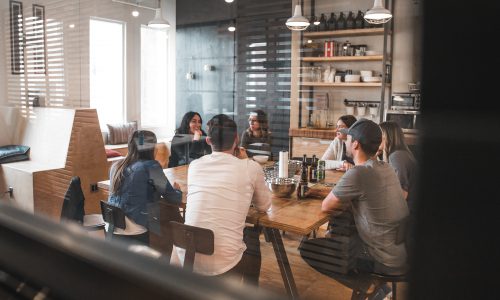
top-left (235, 0), bottom-right (292, 158)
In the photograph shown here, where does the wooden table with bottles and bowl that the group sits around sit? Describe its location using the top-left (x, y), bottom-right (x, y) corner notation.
top-left (98, 165), bottom-right (344, 298)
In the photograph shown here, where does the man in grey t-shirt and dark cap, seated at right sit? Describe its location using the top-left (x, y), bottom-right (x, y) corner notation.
top-left (322, 119), bottom-right (409, 273)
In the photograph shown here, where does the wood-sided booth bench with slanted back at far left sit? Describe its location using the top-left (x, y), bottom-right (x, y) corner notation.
top-left (0, 107), bottom-right (108, 220)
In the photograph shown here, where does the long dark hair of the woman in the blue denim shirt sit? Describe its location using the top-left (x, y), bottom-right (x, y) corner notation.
top-left (110, 130), bottom-right (157, 194)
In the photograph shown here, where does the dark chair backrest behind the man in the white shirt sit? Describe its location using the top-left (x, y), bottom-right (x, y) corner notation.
top-left (170, 221), bottom-right (214, 271)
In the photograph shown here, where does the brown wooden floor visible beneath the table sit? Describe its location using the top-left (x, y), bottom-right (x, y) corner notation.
top-left (259, 227), bottom-right (407, 300)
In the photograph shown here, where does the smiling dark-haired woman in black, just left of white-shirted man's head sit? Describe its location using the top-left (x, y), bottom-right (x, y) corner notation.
top-left (168, 111), bottom-right (212, 168)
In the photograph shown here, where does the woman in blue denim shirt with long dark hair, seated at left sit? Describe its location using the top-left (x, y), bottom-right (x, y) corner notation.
top-left (108, 130), bottom-right (182, 244)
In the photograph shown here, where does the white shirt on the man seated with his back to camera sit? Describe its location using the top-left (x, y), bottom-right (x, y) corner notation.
top-left (174, 152), bottom-right (271, 276)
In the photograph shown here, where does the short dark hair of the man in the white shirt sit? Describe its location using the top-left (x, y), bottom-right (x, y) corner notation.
top-left (207, 114), bottom-right (238, 151)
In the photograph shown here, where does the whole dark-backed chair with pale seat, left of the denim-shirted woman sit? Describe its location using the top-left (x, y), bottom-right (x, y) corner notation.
top-left (61, 176), bottom-right (104, 231)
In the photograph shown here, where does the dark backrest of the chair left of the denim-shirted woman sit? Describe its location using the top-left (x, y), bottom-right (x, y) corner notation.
top-left (61, 176), bottom-right (85, 223)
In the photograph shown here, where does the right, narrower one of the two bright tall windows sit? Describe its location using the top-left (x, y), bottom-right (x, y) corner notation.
top-left (141, 26), bottom-right (168, 128)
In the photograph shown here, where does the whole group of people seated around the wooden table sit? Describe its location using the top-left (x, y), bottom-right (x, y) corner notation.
top-left (109, 111), bottom-right (416, 292)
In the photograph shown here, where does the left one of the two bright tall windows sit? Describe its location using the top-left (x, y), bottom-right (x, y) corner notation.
top-left (89, 19), bottom-right (125, 129)
